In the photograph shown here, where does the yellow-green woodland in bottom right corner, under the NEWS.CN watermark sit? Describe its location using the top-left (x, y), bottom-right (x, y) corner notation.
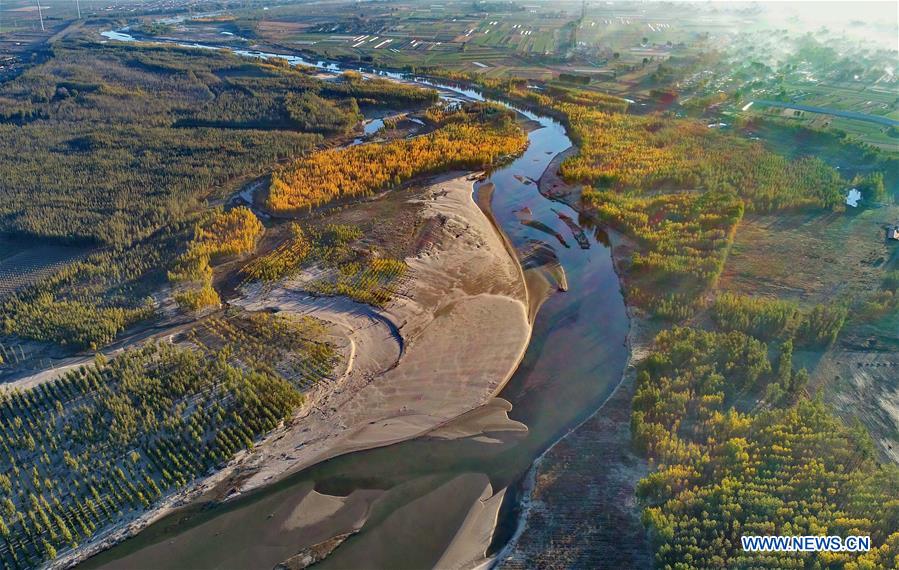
top-left (631, 328), bottom-right (899, 569)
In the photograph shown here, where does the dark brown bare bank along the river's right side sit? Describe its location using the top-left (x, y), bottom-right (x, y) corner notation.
top-left (494, 147), bottom-right (657, 570)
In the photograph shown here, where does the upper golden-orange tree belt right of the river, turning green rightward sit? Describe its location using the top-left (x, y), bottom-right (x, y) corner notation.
top-left (556, 103), bottom-right (845, 211)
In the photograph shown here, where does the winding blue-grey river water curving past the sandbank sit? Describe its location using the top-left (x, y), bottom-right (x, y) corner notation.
top-left (84, 33), bottom-right (628, 569)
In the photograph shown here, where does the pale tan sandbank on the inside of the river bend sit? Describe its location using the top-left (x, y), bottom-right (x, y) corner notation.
top-left (70, 173), bottom-right (531, 567)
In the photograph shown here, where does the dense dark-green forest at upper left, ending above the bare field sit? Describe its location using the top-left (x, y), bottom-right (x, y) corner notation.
top-left (0, 40), bottom-right (436, 247)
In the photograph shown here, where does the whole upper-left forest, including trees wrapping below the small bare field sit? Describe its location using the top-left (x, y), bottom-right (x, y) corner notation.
top-left (0, 40), bottom-right (436, 356)
